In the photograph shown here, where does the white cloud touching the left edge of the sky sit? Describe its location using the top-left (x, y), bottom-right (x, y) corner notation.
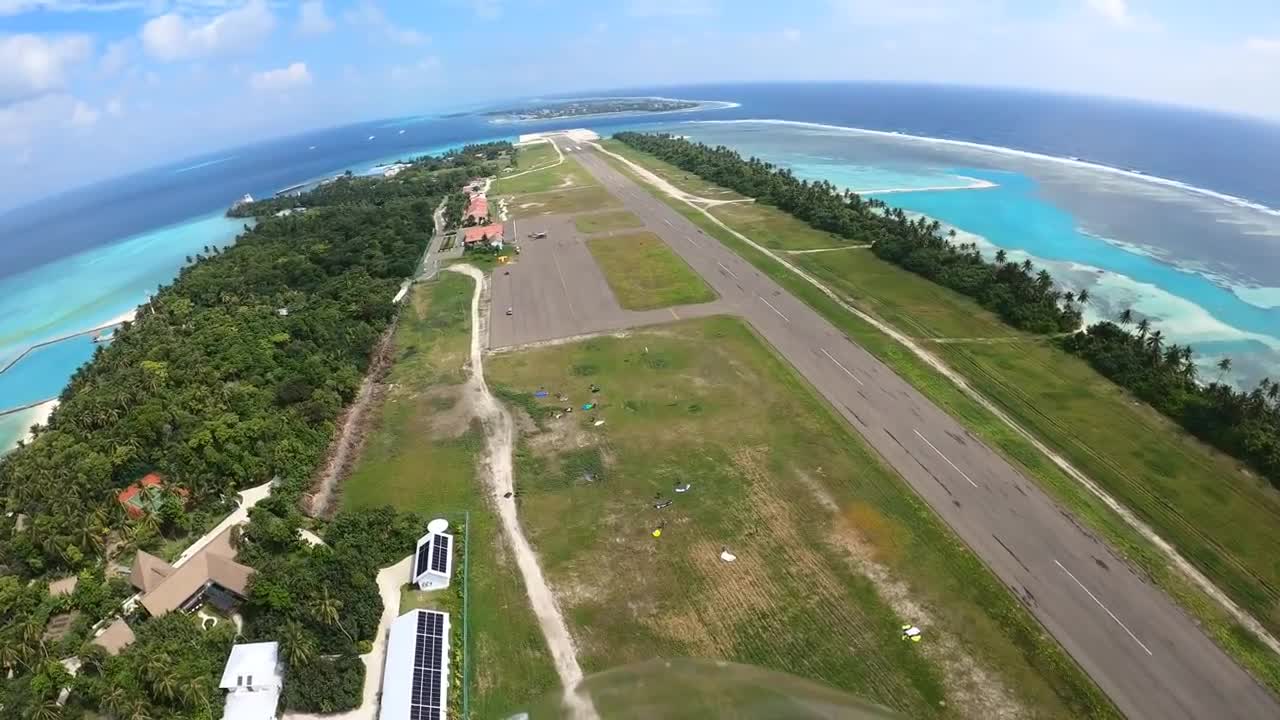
top-left (0, 35), bottom-right (92, 105)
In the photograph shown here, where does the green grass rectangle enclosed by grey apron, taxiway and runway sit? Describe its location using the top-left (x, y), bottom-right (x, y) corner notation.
top-left (586, 232), bottom-right (716, 310)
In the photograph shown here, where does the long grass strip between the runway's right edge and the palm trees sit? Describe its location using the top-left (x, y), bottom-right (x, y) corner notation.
top-left (593, 140), bottom-right (1280, 692)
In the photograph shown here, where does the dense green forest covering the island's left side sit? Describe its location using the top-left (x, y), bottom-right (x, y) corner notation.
top-left (0, 143), bottom-right (496, 720)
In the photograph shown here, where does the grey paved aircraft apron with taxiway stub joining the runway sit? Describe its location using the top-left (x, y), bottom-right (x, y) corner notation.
top-left (489, 215), bottom-right (732, 347)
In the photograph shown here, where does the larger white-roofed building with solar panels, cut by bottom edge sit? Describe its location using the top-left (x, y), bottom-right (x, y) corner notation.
top-left (378, 610), bottom-right (449, 720)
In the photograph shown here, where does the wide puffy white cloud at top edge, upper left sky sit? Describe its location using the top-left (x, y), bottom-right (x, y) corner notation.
top-left (142, 0), bottom-right (275, 60)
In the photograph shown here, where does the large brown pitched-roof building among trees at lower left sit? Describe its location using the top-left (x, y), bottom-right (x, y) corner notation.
top-left (129, 528), bottom-right (253, 618)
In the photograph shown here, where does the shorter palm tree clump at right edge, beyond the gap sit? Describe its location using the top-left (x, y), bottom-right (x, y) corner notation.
top-left (1061, 319), bottom-right (1280, 488)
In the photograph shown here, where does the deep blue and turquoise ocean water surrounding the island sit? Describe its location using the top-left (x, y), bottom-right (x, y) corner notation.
top-left (0, 85), bottom-right (1280, 447)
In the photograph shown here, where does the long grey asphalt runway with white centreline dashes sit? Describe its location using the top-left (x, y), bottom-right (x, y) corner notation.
top-left (556, 138), bottom-right (1280, 720)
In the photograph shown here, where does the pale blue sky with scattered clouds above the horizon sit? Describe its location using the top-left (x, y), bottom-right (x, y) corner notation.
top-left (0, 0), bottom-right (1280, 202)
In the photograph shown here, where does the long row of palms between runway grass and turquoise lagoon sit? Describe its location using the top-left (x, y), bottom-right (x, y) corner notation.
top-left (614, 132), bottom-right (1080, 333)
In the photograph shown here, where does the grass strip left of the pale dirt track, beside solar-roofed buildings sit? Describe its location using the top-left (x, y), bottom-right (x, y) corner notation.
top-left (342, 273), bottom-right (558, 717)
